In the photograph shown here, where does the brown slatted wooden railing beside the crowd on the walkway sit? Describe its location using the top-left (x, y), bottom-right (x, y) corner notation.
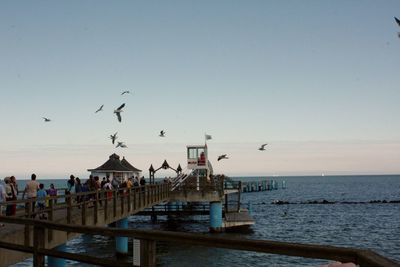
top-left (0, 183), bottom-right (170, 225)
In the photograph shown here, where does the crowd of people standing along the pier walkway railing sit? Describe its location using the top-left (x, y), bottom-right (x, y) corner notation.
top-left (0, 174), bottom-right (146, 227)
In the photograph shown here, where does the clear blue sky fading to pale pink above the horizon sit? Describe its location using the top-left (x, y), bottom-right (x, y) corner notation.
top-left (0, 0), bottom-right (400, 179)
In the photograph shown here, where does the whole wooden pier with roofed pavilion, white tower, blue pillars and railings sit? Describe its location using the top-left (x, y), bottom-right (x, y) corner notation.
top-left (0, 145), bottom-right (400, 267)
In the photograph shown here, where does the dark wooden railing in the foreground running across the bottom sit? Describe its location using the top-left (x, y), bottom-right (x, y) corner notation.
top-left (0, 216), bottom-right (400, 267)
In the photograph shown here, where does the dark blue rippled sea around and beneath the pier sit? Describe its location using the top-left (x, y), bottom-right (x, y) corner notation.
top-left (13, 175), bottom-right (400, 267)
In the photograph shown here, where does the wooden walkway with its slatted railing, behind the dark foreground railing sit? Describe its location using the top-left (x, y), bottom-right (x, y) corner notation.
top-left (0, 184), bottom-right (170, 266)
